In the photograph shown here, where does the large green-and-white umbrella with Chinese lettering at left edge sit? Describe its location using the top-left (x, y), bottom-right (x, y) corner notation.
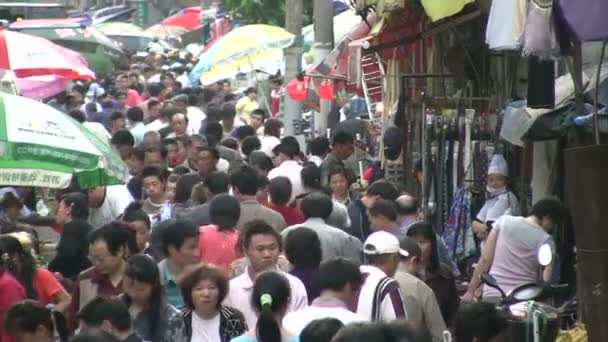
top-left (0, 93), bottom-right (128, 189)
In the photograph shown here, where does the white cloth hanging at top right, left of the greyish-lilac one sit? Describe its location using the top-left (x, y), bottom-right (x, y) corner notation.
top-left (486, 0), bottom-right (526, 50)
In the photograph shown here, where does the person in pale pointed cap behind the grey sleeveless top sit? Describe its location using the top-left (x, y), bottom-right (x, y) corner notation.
top-left (473, 154), bottom-right (520, 242)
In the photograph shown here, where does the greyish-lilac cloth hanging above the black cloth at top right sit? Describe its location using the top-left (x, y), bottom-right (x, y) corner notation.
top-left (522, 0), bottom-right (560, 60)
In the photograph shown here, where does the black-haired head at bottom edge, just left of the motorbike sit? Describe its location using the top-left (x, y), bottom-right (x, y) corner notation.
top-left (454, 302), bottom-right (508, 342)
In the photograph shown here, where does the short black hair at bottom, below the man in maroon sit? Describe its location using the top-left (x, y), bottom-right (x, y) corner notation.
top-left (77, 297), bottom-right (132, 332)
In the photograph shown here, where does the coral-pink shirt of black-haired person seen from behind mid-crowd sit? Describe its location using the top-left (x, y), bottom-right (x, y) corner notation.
top-left (198, 225), bottom-right (241, 272)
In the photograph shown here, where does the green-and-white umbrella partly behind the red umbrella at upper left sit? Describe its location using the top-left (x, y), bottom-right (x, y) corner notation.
top-left (10, 26), bottom-right (126, 74)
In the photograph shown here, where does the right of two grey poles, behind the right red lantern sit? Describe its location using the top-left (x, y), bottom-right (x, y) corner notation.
top-left (313, 0), bottom-right (334, 136)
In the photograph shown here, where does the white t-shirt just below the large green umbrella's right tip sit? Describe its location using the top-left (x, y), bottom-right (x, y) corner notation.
top-left (89, 185), bottom-right (133, 229)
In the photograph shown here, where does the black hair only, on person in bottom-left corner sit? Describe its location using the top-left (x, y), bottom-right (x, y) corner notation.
top-left (3, 300), bottom-right (54, 336)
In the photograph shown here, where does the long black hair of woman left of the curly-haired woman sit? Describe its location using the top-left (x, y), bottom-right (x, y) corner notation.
top-left (123, 254), bottom-right (164, 341)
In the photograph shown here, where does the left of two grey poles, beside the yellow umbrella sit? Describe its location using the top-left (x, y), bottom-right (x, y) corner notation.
top-left (283, 0), bottom-right (310, 139)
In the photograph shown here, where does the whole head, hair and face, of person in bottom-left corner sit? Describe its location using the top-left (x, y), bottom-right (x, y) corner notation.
top-left (2, 300), bottom-right (55, 342)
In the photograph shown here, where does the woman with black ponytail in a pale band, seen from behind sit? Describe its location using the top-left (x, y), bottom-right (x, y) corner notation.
top-left (232, 271), bottom-right (299, 342)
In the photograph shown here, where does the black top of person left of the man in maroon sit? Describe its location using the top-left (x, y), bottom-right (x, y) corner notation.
top-left (48, 220), bottom-right (93, 279)
